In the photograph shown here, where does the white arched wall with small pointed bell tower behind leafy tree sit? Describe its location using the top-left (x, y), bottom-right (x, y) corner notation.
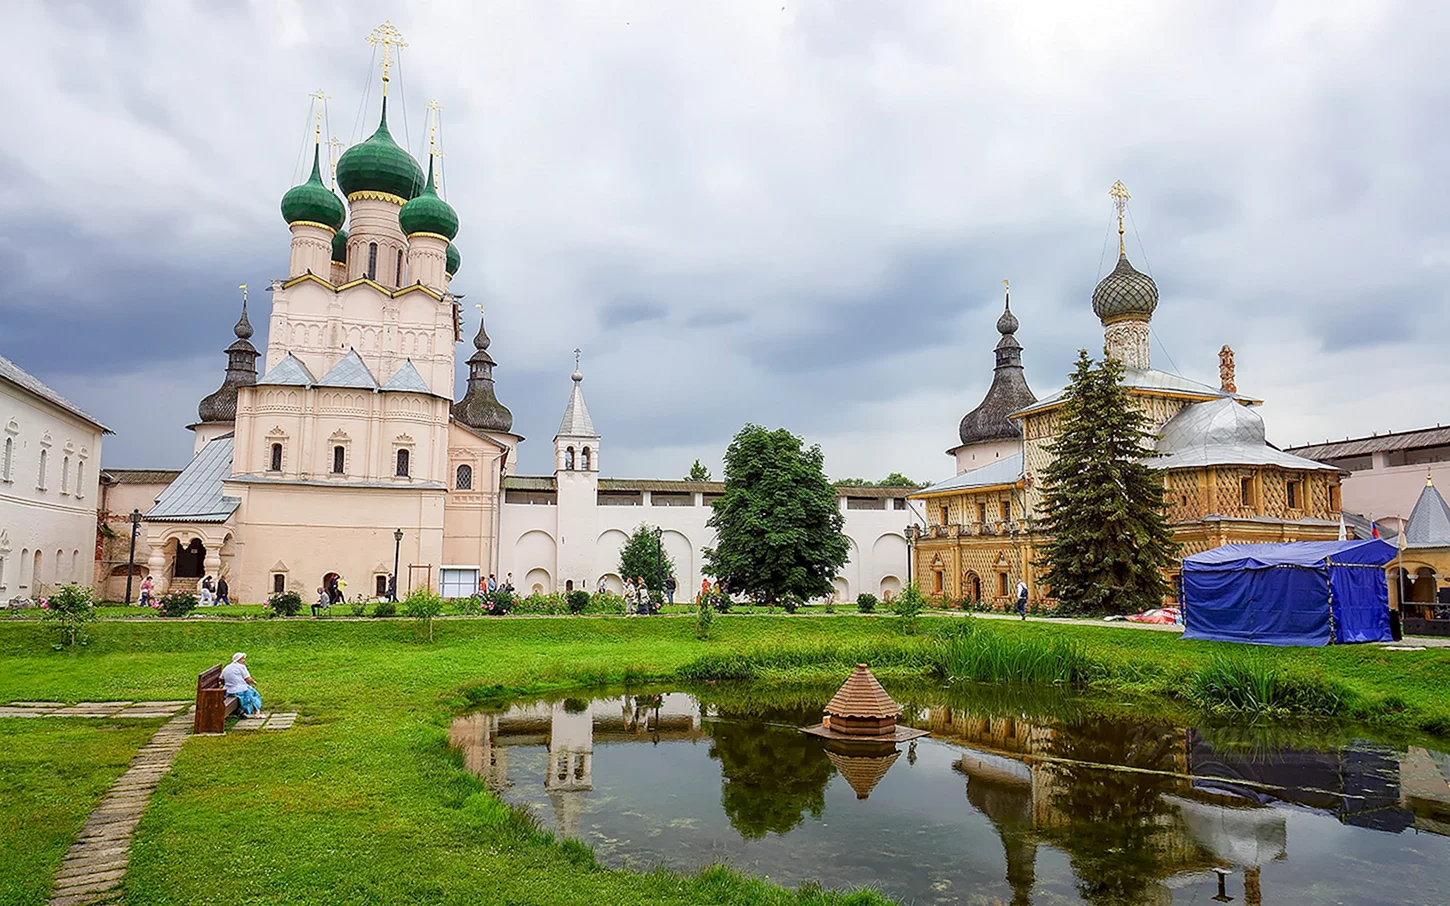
top-left (493, 371), bottom-right (921, 600)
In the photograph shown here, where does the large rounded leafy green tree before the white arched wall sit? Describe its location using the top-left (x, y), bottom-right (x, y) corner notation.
top-left (705, 425), bottom-right (850, 606)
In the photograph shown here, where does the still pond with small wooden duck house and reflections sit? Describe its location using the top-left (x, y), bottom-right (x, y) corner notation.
top-left (451, 684), bottom-right (1450, 906)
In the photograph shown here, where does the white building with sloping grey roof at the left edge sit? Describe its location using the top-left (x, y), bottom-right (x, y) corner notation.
top-left (0, 358), bottom-right (110, 600)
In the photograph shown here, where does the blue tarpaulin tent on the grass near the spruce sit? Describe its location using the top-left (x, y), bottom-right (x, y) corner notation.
top-left (1183, 538), bottom-right (1395, 645)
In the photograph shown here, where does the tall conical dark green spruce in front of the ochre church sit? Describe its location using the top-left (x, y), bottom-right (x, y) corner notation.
top-left (1040, 351), bottom-right (1177, 613)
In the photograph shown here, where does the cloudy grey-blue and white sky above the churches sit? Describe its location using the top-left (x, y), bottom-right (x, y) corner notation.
top-left (0, 0), bottom-right (1450, 480)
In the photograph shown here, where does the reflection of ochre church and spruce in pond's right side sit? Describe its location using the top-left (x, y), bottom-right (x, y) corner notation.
top-left (918, 707), bottom-right (1450, 906)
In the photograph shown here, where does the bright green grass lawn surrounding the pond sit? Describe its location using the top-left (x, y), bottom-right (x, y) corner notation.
top-left (0, 615), bottom-right (1450, 906)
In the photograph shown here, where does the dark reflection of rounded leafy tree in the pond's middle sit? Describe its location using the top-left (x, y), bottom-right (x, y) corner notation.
top-left (703, 709), bottom-right (835, 839)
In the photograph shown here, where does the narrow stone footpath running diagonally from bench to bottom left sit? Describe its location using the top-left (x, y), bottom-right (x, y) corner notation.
top-left (46, 703), bottom-right (191, 906)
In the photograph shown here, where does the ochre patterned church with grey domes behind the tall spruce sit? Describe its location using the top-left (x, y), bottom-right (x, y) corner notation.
top-left (912, 183), bottom-right (1341, 607)
